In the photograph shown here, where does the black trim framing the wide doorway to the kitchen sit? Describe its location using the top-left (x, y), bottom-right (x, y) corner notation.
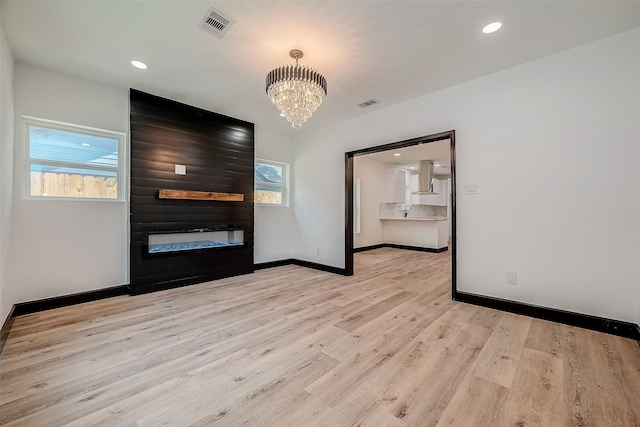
top-left (344, 130), bottom-right (457, 300)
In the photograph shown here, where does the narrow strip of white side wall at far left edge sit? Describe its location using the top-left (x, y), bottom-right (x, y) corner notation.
top-left (0, 16), bottom-right (15, 326)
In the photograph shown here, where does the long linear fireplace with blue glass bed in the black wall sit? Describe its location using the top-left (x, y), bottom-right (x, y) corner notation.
top-left (143, 226), bottom-right (246, 255)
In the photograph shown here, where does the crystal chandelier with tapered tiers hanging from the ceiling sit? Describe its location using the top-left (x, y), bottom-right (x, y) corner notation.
top-left (267, 49), bottom-right (327, 128)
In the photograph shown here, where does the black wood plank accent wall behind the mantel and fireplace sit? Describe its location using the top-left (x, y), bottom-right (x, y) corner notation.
top-left (130, 89), bottom-right (254, 294)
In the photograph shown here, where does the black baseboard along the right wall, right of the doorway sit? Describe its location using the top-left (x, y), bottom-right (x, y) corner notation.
top-left (454, 291), bottom-right (640, 341)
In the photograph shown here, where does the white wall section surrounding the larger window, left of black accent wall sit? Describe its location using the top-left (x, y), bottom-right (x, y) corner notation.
top-left (11, 62), bottom-right (129, 302)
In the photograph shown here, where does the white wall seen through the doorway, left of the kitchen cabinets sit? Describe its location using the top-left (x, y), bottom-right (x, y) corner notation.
top-left (353, 156), bottom-right (393, 248)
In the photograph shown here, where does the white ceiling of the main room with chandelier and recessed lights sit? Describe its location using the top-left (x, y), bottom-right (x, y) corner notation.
top-left (0, 0), bottom-right (640, 135)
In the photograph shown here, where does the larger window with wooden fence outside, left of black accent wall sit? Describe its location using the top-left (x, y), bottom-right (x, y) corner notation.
top-left (23, 117), bottom-right (125, 201)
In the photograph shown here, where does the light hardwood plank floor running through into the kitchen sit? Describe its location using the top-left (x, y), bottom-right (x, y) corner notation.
top-left (0, 249), bottom-right (640, 427)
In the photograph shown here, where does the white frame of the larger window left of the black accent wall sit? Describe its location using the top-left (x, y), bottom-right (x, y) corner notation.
top-left (22, 115), bottom-right (127, 203)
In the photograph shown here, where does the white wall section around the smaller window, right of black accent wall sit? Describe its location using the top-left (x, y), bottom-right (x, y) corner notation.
top-left (254, 127), bottom-right (296, 263)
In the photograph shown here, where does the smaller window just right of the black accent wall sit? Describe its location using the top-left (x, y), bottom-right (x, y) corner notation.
top-left (254, 159), bottom-right (289, 206)
